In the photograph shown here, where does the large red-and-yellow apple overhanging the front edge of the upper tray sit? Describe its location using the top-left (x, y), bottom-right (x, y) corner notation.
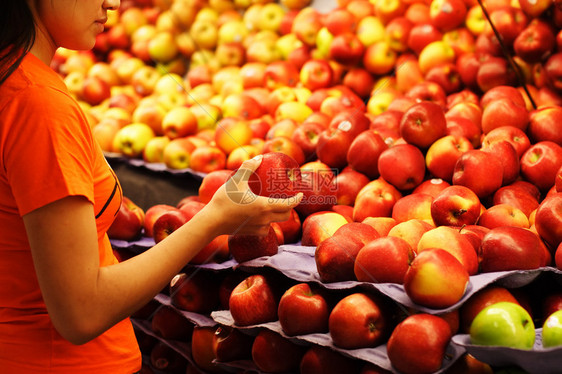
top-left (404, 248), bottom-right (470, 309)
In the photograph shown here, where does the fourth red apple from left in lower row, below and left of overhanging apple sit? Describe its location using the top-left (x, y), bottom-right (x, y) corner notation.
top-left (329, 293), bottom-right (391, 349)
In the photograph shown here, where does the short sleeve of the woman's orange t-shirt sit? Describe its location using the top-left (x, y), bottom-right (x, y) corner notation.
top-left (2, 86), bottom-right (95, 216)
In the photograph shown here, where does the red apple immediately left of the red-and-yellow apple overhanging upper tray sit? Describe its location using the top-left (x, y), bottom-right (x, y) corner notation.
top-left (354, 235), bottom-right (415, 284)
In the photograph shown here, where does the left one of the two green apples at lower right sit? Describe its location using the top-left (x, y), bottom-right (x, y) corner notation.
top-left (470, 301), bottom-right (535, 349)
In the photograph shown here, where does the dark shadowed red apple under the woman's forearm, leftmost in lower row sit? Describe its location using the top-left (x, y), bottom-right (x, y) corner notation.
top-left (170, 270), bottom-right (219, 313)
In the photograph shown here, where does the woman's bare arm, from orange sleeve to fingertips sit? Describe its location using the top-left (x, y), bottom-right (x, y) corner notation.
top-left (24, 160), bottom-right (300, 344)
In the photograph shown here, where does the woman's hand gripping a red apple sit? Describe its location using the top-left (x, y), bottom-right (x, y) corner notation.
top-left (204, 156), bottom-right (302, 235)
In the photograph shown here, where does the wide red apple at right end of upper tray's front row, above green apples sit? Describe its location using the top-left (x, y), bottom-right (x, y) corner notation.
top-left (474, 226), bottom-right (545, 273)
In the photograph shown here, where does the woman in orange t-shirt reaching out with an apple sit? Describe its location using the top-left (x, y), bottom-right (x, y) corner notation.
top-left (0, 0), bottom-right (301, 374)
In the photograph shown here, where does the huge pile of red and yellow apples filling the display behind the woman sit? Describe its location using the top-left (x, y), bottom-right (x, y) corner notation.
top-left (87, 0), bottom-right (562, 373)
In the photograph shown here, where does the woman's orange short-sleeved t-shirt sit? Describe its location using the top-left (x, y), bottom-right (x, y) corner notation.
top-left (0, 53), bottom-right (141, 374)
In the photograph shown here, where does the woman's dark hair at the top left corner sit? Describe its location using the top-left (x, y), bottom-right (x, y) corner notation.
top-left (0, 0), bottom-right (35, 85)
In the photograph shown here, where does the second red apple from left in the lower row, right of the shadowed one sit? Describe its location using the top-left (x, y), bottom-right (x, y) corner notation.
top-left (228, 274), bottom-right (278, 326)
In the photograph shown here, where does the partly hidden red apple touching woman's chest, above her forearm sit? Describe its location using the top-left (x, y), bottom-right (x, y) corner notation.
top-left (107, 196), bottom-right (145, 240)
